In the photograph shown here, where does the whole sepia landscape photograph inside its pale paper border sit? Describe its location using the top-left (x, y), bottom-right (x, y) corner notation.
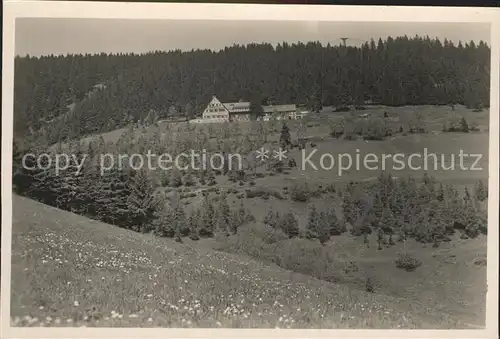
top-left (2, 4), bottom-right (498, 338)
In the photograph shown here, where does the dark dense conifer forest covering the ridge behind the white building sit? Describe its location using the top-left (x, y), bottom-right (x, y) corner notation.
top-left (14, 36), bottom-right (490, 143)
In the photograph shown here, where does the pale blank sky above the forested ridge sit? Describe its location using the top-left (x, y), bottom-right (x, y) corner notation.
top-left (15, 18), bottom-right (490, 56)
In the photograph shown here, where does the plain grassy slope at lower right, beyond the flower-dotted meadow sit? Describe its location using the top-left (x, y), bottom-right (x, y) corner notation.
top-left (209, 228), bottom-right (487, 327)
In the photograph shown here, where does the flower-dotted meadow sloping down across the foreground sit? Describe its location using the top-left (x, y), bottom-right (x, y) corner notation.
top-left (11, 196), bottom-right (480, 328)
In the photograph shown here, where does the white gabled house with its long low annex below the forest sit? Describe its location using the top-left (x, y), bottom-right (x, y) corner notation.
top-left (191, 95), bottom-right (305, 123)
